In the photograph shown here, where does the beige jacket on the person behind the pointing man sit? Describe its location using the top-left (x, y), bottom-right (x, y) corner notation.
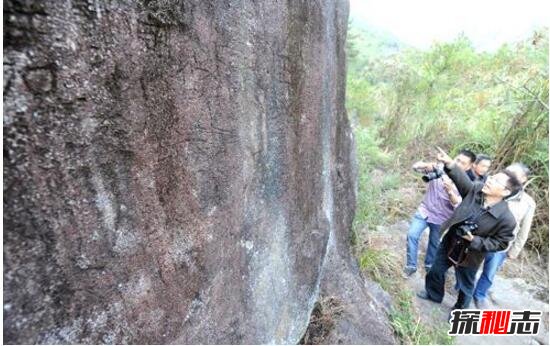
top-left (507, 191), bottom-right (537, 258)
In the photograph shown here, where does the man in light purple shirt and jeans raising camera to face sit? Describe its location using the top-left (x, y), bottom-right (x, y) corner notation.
top-left (404, 150), bottom-right (476, 277)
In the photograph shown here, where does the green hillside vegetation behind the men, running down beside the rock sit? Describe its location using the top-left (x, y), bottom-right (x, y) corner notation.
top-left (346, 23), bottom-right (548, 344)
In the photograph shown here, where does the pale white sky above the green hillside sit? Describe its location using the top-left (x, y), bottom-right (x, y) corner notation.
top-left (350, 0), bottom-right (550, 51)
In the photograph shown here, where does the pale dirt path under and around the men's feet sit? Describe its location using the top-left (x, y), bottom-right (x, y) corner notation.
top-left (368, 220), bottom-right (549, 345)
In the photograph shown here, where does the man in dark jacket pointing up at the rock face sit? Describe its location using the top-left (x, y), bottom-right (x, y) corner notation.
top-left (417, 148), bottom-right (521, 309)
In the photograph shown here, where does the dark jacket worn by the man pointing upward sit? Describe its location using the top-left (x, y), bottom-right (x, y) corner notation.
top-left (441, 163), bottom-right (516, 267)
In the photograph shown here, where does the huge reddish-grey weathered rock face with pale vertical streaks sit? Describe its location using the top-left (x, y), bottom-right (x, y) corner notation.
top-left (4, 0), bottom-right (392, 343)
